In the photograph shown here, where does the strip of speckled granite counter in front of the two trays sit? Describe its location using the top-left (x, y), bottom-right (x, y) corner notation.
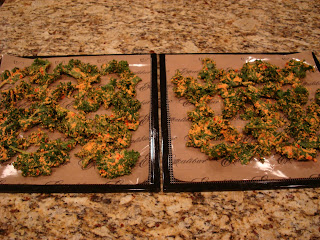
top-left (0, 190), bottom-right (320, 239)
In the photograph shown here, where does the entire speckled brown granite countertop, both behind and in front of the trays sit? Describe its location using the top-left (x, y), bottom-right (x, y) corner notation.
top-left (0, 0), bottom-right (320, 239)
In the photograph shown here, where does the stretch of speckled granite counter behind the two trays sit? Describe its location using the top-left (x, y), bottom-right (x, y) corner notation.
top-left (0, 0), bottom-right (320, 55)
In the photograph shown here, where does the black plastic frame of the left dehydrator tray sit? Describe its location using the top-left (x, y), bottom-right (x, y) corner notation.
top-left (0, 53), bottom-right (161, 193)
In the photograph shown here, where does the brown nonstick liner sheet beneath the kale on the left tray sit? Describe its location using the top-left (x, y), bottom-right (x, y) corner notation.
top-left (0, 54), bottom-right (159, 192)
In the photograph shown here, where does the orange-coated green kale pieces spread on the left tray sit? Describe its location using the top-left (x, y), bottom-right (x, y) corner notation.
top-left (0, 59), bottom-right (141, 178)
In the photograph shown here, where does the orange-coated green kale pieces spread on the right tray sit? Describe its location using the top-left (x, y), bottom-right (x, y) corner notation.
top-left (171, 58), bottom-right (320, 164)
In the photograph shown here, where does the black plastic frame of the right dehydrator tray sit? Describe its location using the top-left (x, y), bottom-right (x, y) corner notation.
top-left (159, 52), bottom-right (320, 192)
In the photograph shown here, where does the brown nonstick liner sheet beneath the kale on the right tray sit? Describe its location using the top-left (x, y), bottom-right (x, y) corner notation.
top-left (160, 52), bottom-right (320, 191)
